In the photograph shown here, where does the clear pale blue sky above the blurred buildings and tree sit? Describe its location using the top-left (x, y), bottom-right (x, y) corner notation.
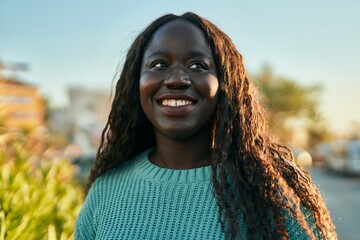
top-left (0, 0), bottom-right (360, 133)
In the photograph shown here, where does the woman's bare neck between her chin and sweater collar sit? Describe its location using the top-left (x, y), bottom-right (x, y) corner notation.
top-left (150, 129), bottom-right (211, 169)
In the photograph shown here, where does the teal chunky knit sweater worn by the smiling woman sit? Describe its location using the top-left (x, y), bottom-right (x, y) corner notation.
top-left (75, 151), bottom-right (320, 240)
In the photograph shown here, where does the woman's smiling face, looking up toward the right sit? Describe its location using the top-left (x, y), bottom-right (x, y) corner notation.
top-left (139, 20), bottom-right (219, 139)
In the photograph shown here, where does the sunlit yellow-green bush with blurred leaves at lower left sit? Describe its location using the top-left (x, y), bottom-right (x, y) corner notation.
top-left (0, 131), bottom-right (84, 240)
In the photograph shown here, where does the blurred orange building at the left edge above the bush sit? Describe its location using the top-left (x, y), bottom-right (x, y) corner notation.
top-left (0, 76), bottom-right (45, 129)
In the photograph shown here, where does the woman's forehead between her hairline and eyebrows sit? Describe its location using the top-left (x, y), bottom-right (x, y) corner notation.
top-left (144, 20), bottom-right (212, 57)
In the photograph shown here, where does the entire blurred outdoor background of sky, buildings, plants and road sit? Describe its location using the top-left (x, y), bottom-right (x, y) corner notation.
top-left (0, 0), bottom-right (360, 239)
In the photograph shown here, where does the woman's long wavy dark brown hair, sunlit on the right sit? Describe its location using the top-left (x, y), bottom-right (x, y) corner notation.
top-left (87, 13), bottom-right (336, 239)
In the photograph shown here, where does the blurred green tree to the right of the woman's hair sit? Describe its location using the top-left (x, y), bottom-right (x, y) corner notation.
top-left (254, 66), bottom-right (329, 147)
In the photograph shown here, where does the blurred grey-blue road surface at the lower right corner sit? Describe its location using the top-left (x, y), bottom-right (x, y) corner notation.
top-left (309, 169), bottom-right (360, 240)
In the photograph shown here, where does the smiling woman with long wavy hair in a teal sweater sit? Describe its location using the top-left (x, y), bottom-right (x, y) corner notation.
top-left (75, 13), bottom-right (336, 239)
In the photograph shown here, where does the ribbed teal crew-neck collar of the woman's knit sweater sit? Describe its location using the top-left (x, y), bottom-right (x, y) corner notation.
top-left (134, 149), bottom-right (211, 184)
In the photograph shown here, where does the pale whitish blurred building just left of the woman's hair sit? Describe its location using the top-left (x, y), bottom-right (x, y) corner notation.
top-left (49, 87), bottom-right (110, 151)
